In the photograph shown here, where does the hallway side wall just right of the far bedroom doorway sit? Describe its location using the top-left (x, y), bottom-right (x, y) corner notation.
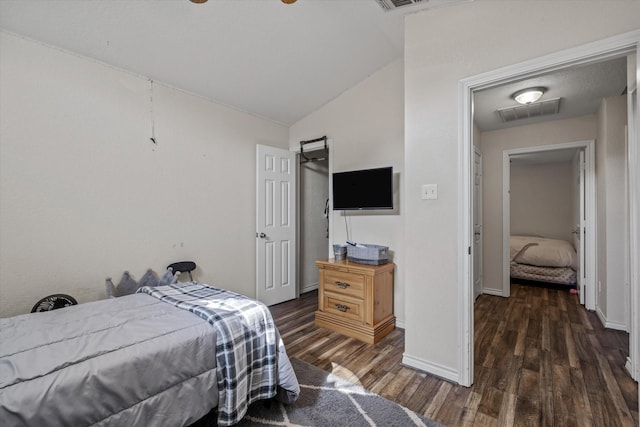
top-left (596, 96), bottom-right (629, 330)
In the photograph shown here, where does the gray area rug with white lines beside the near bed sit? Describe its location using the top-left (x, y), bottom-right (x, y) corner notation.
top-left (232, 358), bottom-right (440, 427)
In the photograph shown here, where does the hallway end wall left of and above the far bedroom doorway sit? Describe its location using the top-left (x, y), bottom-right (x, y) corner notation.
top-left (481, 115), bottom-right (597, 294)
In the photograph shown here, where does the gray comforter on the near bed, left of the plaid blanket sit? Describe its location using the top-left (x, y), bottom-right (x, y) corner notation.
top-left (0, 294), bottom-right (218, 426)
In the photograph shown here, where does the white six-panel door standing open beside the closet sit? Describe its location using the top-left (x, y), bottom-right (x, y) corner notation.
top-left (256, 145), bottom-right (297, 305)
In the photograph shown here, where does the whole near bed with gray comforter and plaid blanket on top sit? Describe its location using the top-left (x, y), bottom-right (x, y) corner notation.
top-left (0, 283), bottom-right (299, 426)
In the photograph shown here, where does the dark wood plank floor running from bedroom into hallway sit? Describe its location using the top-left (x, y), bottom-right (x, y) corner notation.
top-left (271, 284), bottom-right (638, 427)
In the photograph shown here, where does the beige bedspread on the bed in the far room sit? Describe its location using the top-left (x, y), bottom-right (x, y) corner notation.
top-left (509, 236), bottom-right (578, 269)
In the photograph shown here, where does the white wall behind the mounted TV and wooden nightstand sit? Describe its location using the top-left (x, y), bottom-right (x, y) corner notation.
top-left (290, 59), bottom-right (405, 326)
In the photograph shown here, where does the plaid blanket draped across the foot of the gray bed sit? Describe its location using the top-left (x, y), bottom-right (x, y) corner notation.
top-left (138, 282), bottom-right (278, 425)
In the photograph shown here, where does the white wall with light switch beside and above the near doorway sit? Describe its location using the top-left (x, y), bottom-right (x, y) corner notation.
top-left (403, 0), bottom-right (640, 378)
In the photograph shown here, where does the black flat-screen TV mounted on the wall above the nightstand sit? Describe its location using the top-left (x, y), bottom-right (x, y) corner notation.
top-left (333, 166), bottom-right (393, 211)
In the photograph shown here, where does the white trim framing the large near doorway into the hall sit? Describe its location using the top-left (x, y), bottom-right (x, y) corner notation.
top-left (458, 30), bottom-right (640, 386)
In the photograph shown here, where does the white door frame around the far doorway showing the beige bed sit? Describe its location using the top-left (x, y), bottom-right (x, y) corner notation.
top-left (502, 140), bottom-right (596, 310)
